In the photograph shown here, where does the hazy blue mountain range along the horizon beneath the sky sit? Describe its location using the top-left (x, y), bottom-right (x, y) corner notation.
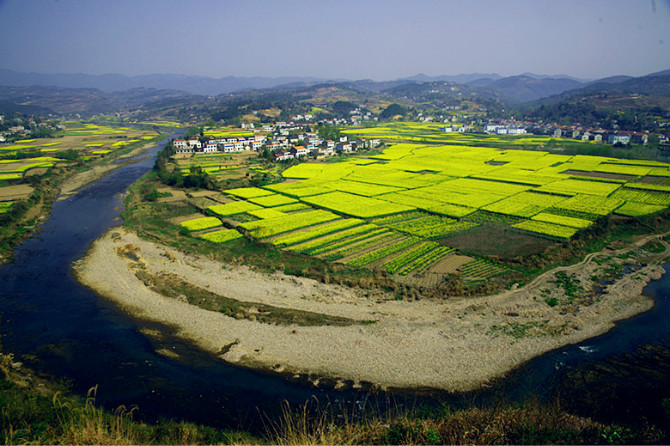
top-left (0, 70), bottom-right (670, 115)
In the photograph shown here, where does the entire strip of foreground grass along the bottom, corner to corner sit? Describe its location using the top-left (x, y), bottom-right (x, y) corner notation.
top-left (0, 354), bottom-right (668, 445)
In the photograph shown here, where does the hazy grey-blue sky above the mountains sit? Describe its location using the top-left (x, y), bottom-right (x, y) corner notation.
top-left (0, 0), bottom-right (670, 80)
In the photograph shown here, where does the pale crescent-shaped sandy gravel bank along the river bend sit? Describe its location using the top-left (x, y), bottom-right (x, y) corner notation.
top-left (75, 229), bottom-right (663, 391)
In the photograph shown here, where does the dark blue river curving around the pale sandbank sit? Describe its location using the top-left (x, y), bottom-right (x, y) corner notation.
top-left (0, 137), bottom-right (670, 431)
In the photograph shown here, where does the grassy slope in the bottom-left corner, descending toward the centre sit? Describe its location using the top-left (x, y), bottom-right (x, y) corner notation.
top-left (0, 353), bottom-right (263, 445)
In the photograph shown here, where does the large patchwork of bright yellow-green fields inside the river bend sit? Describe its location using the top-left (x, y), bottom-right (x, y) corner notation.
top-left (181, 143), bottom-right (670, 284)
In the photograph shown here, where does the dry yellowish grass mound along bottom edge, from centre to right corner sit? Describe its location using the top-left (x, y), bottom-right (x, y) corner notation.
top-left (268, 402), bottom-right (665, 445)
